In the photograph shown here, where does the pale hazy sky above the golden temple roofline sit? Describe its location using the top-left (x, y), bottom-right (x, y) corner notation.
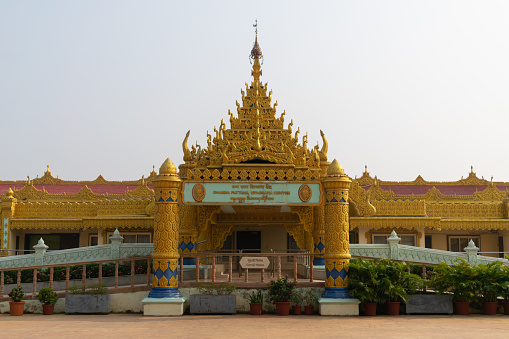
top-left (0, 0), bottom-right (509, 181)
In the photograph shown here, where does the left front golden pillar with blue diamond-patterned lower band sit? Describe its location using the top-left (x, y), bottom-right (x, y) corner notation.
top-left (148, 158), bottom-right (181, 298)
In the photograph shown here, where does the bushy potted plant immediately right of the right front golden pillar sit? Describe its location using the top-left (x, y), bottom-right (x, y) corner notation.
top-left (348, 258), bottom-right (380, 316)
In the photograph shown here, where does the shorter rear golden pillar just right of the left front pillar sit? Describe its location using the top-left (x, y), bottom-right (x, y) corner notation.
top-left (179, 205), bottom-right (198, 265)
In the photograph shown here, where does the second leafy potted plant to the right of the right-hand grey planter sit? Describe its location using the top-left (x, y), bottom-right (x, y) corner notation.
top-left (474, 261), bottom-right (509, 315)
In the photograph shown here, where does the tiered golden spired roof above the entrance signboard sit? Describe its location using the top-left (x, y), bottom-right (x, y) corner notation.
top-left (181, 33), bottom-right (328, 179)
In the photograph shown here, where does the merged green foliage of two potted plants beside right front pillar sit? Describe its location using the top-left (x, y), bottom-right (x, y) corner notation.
top-left (348, 258), bottom-right (423, 303)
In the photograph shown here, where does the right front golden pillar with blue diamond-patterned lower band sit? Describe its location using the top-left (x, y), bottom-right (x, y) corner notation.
top-left (322, 160), bottom-right (352, 298)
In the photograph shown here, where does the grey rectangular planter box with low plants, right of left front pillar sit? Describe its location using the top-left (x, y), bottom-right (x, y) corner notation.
top-left (189, 284), bottom-right (237, 314)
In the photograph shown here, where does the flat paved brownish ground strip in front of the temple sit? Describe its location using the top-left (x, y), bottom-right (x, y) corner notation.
top-left (0, 314), bottom-right (509, 339)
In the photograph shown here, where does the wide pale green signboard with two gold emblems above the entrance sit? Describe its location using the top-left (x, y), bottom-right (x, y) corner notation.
top-left (183, 181), bottom-right (321, 205)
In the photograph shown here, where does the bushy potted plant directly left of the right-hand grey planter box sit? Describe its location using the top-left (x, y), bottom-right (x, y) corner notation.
top-left (376, 259), bottom-right (421, 315)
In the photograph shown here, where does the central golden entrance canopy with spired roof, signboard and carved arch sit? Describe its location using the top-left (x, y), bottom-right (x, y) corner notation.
top-left (179, 32), bottom-right (330, 252)
